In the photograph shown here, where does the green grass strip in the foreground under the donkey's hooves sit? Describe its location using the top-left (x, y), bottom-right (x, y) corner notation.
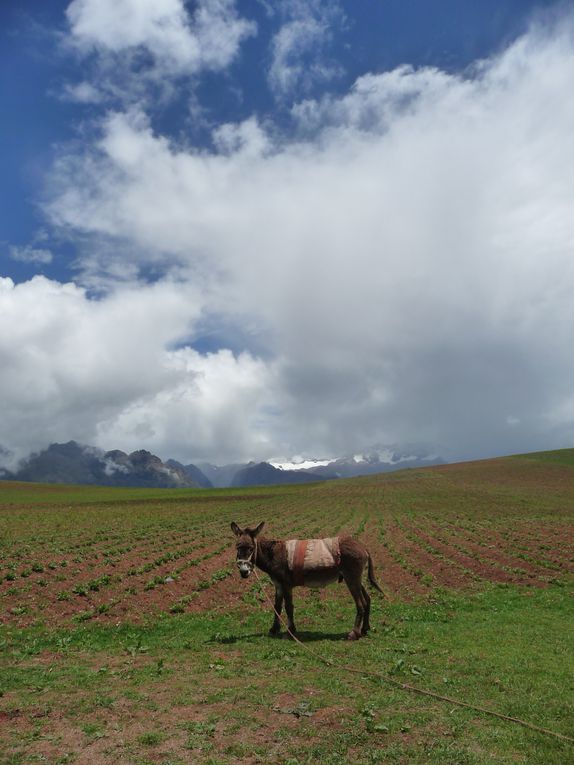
top-left (1, 586), bottom-right (574, 765)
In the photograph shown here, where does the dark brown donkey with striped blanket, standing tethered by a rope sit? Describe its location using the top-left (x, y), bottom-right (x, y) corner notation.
top-left (231, 521), bottom-right (385, 640)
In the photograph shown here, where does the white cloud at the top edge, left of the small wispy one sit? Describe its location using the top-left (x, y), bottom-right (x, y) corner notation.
top-left (64, 0), bottom-right (256, 103)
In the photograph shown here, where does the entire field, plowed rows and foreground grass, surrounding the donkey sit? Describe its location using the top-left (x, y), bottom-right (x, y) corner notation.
top-left (0, 450), bottom-right (574, 765)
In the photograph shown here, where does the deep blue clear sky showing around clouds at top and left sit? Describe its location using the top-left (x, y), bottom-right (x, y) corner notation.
top-left (0, 0), bottom-right (552, 280)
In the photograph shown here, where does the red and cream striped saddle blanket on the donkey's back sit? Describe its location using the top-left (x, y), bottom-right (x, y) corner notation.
top-left (285, 537), bottom-right (341, 587)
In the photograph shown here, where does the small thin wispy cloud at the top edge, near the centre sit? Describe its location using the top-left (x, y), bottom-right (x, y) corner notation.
top-left (267, 0), bottom-right (344, 100)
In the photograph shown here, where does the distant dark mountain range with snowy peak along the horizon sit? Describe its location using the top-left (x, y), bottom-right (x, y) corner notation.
top-left (0, 441), bottom-right (444, 488)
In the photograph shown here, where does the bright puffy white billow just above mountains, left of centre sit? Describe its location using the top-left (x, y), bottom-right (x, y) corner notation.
top-left (98, 347), bottom-right (273, 460)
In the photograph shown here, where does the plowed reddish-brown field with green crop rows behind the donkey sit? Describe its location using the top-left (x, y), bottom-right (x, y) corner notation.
top-left (0, 458), bottom-right (574, 626)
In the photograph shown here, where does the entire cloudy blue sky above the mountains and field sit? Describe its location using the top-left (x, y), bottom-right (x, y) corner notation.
top-left (0, 0), bottom-right (574, 465)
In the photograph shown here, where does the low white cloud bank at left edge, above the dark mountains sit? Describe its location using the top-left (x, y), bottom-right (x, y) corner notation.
top-left (0, 277), bottom-right (276, 463)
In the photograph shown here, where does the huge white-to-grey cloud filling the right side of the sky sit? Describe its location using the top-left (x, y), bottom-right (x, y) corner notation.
top-left (23, 13), bottom-right (574, 457)
